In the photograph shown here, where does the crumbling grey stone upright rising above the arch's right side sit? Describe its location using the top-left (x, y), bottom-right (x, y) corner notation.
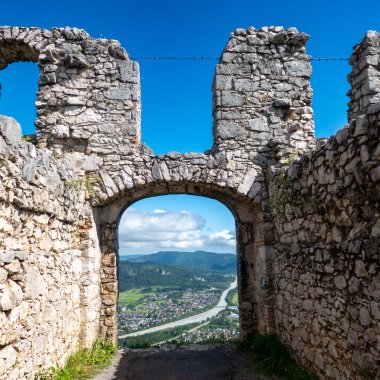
top-left (213, 27), bottom-right (315, 161)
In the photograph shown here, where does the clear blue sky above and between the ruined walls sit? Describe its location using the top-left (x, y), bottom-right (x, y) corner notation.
top-left (0, 0), bottom-right (380, 255)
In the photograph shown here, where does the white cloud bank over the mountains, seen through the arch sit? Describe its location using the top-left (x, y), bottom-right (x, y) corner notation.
top-left (119, 208), bottom-right (236, 254)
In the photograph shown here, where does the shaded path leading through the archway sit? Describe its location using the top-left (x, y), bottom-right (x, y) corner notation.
top-left (95, 344), bottom-right (268, 380)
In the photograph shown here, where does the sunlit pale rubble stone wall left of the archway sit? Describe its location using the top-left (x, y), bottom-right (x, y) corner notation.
top-left (0, 116), bottom-right (100, 380)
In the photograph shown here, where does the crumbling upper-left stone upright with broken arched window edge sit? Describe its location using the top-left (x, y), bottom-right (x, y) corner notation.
top-left (0, 27), bottom-right (141, 155)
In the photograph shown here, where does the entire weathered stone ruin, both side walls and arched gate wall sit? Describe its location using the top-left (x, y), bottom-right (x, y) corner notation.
top-left (0, 27), bottom-right (380, 380)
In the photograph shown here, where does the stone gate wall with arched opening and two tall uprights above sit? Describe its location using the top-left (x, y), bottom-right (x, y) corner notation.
top-left (0, 27), bottom-right (315, 348)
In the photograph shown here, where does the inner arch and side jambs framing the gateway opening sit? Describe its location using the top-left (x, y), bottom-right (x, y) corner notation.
top-left (94, 183), bottom-right (274, 341)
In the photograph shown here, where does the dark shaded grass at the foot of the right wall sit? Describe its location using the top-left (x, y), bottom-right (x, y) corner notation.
top-left (240, 334), bottom-right (319, 380)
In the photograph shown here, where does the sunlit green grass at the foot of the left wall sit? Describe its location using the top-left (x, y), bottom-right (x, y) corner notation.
top-left (35, 340), bottom-right (117, 380)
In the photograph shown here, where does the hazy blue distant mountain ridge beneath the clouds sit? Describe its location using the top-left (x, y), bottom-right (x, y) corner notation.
top-left (120, 251), bottom-right (237, 274)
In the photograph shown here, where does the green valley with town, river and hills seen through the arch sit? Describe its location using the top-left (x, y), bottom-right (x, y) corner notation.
top-left (118, 251), bottom-right (239, 347)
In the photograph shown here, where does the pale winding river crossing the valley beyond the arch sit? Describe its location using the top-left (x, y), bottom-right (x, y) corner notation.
top-left (119, 277), bottom-right (237, 339)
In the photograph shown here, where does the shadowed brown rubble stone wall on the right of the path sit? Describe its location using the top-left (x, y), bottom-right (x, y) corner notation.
top-left (270, 32), bottom-right (380, 379)
